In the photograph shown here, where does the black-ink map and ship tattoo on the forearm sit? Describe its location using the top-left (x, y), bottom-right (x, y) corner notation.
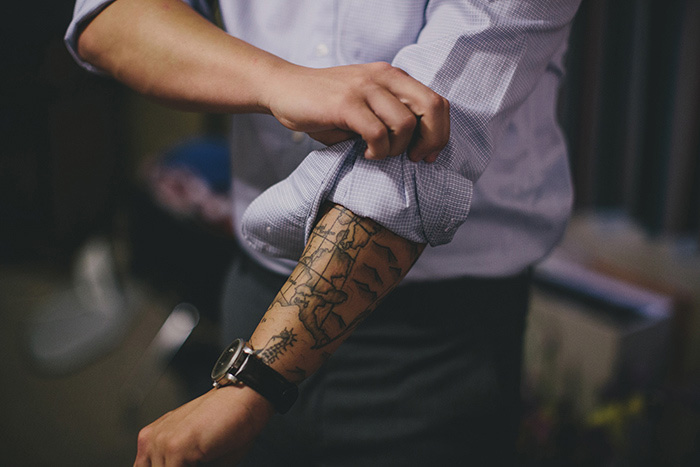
top-left (260, 205), bottom-right (422, 354)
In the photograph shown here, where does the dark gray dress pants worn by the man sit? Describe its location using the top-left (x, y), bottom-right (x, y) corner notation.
top-left (222, 254), bottom-right (531, 467)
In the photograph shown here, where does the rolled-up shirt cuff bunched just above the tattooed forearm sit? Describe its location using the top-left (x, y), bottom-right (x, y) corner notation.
top-left (241, 140), bottom-right (473, 259)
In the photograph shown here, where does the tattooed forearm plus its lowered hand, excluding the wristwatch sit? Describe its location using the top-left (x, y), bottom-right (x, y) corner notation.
top-left (135, 205), bottom-right (424, 466)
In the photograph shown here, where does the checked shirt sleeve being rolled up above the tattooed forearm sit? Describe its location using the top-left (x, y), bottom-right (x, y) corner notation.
top-left (242, 0), bottom-right (579, 258)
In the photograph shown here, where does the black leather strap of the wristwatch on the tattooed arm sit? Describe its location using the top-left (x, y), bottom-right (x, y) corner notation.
top-left (236, 348), bottom-right (299, 413)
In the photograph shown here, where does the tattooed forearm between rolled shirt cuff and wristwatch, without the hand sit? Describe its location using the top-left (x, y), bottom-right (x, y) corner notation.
top-left (250, 205), bottom-right (424, 382)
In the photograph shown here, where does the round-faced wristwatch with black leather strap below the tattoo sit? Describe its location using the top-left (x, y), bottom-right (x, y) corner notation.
top-left (211, 339), bottom-right (299, 413)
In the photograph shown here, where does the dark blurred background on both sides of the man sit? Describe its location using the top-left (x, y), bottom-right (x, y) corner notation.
top-left (0, 0), bottom-right (700, 466)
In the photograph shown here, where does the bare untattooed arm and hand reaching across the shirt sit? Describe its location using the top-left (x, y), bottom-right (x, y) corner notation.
top-left (78, 0), bottom-right (450, 162)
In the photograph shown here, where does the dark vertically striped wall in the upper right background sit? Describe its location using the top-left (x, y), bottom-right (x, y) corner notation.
top-left (561, 0), bottom-right (700, 239)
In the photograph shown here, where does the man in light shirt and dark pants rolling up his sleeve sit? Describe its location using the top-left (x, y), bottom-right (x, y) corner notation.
top-left (67, 0), bottom-right (578, 465)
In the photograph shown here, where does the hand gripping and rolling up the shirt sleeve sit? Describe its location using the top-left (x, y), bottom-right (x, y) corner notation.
top-left (267, 62), bottom-right (450, 162)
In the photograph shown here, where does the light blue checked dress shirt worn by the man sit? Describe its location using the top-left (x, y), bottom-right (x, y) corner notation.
top-left (66, 0), bottom-right (579, 281)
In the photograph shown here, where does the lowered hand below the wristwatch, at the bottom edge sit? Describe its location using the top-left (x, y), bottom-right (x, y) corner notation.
top-left (134, 386), bottom-right (274, 467)
